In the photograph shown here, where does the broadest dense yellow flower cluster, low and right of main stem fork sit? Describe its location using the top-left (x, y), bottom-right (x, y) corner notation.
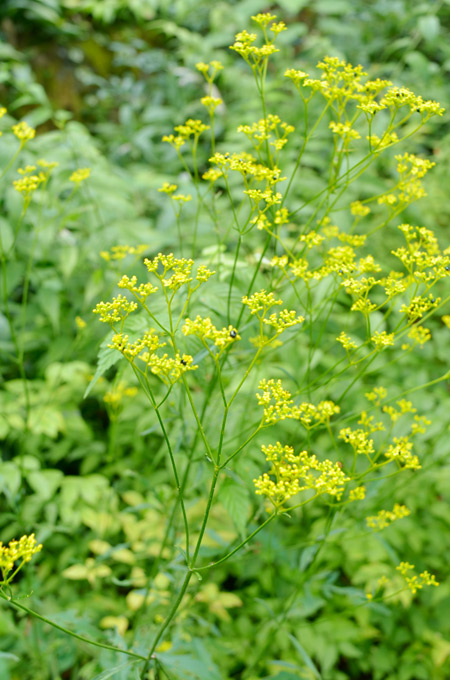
top-left (253, 442), bottom-right (350, 508)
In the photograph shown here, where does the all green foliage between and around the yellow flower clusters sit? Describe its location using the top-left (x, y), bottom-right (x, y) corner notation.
top-left (0, 0), bottom-right (450, 680)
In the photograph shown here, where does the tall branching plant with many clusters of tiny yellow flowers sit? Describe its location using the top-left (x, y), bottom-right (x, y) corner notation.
top-left (1, 14), bottom-right (450, 679)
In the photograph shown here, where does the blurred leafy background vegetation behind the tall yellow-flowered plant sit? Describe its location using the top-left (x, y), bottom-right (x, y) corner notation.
top-left (0, 0), bottom-right (450, 680)
